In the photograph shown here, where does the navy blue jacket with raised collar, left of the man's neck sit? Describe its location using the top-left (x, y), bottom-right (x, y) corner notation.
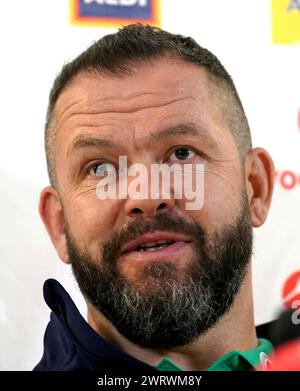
top-left (33, 279), bottom-right (158, 373)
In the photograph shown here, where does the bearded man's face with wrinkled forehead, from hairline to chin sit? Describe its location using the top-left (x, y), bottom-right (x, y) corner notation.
top-left (55, 59), bottom-right (252, 347)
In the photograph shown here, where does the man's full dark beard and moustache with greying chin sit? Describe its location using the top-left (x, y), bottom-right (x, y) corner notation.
top-left (66, 195), bottom-right (252, 348)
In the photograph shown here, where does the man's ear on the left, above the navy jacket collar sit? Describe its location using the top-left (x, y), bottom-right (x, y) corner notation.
top-left (39, 186), bottom-right (70, 263)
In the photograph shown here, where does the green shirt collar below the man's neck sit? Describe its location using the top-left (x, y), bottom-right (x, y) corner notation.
top-left (155, 338), bottom-right (273, 371)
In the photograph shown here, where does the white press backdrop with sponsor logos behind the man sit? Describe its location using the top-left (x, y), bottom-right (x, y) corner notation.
top-left (0, 0), bottom-right (300, 370)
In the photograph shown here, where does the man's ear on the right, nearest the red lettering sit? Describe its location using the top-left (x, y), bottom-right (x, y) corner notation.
top-left (245, 148), bottom-right (275, 227)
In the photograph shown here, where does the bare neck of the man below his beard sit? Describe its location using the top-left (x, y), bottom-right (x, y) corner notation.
top-left (88, 265), bottom-right (258, 371)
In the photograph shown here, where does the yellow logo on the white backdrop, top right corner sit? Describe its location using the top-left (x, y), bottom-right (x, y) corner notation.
top-left (271, 0), bottom-right (300, 44)
